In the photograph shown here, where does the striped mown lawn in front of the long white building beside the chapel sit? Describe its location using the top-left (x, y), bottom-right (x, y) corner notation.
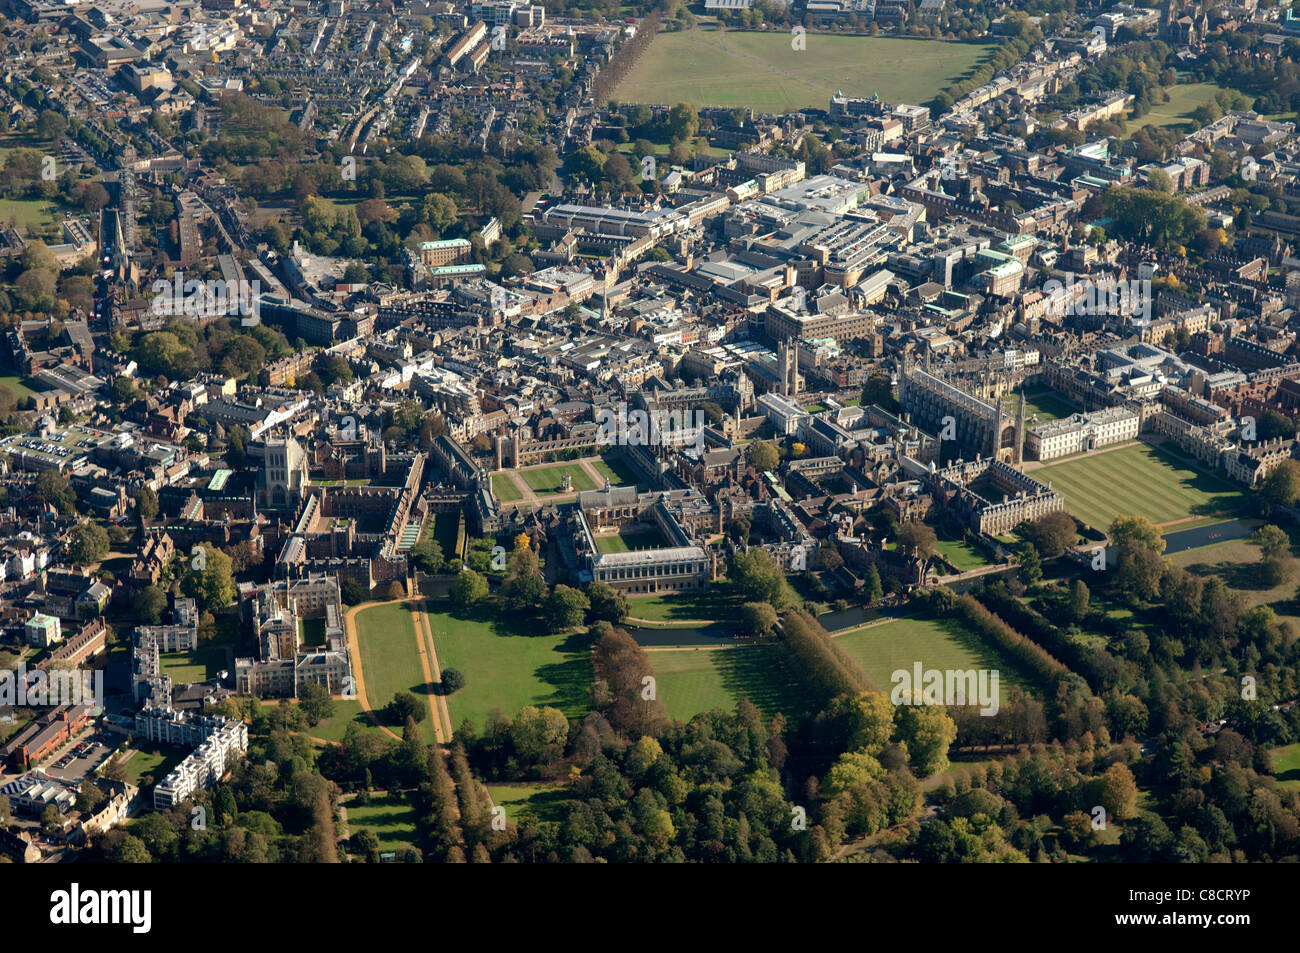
top-left (1032, 443), bottom-right (1242, 529)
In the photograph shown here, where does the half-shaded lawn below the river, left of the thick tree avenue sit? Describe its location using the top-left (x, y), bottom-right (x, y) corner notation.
top-left (647, 645), bottom-right (807, 722)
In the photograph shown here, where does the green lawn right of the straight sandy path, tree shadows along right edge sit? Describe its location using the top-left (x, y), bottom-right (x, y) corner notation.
top-left (429, 611), bottom-right (592, 731)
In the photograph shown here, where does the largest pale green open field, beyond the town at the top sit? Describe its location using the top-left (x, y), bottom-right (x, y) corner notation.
top-left (614, 27), bottom-right (993, 112)
